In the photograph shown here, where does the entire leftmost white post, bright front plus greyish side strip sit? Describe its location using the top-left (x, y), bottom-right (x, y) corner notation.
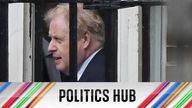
top-left (8, 3), bottom-right (35, 82)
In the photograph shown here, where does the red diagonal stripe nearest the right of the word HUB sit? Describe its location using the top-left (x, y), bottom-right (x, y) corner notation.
top-left (138, 82), bottom-right (169, 108)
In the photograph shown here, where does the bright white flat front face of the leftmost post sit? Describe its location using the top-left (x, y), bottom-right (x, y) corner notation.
top-left (8, 3), bottom-right (24, 82)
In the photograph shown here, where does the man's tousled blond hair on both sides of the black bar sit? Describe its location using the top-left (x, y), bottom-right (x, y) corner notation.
top-left (44, 3), bottom-right (105, 44)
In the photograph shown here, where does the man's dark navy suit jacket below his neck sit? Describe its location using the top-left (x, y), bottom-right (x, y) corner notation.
top-left (79, 49), bottom-right (106, 82)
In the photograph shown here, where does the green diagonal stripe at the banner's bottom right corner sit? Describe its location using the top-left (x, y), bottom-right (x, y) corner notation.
top-left (174, 90), bottom-right (192, 108)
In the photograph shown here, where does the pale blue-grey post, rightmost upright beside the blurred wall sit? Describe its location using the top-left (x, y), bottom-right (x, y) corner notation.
top-left (150, 6), bottom-right (167, 82)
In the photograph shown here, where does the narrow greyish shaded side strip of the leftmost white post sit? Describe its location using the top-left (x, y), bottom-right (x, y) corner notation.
top-left (23, 3), bottom-right (35, 81)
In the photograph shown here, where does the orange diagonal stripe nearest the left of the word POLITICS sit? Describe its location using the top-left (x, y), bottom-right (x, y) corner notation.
top-left (26, 82), bottom-right (55, 108)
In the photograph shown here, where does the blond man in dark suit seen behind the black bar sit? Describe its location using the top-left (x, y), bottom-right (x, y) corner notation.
top-left (45, 3), bottom-right (106, 82)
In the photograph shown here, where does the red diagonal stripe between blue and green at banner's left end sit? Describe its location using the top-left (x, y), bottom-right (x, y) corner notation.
top-left (2, 82), bottom-right (32, 108)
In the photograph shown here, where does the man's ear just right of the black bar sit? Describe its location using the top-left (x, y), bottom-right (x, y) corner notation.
top-left (83, 31), bottom-right (92, 49)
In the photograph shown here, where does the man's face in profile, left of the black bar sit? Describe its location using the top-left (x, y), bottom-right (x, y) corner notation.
top-left (48, 14), bottom-right (69, 74)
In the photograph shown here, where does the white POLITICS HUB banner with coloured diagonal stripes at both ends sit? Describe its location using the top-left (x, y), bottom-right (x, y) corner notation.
top-left (0, 82), bottom-right (192, 108)
